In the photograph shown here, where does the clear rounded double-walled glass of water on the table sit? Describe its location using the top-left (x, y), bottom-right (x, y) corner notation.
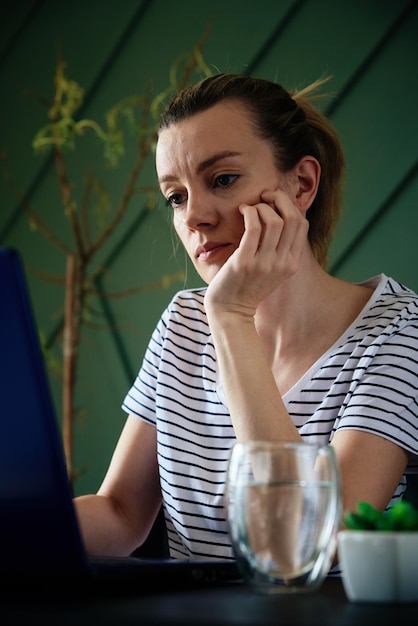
top-left (225, 441), bottom-right (341, 593)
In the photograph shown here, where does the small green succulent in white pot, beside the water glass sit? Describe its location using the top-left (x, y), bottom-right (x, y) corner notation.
top-left (338, 501), bottom-right (418, 602)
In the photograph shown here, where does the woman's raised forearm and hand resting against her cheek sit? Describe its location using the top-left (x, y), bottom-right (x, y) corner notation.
top-left (205, 190), bottom-right (308, 441)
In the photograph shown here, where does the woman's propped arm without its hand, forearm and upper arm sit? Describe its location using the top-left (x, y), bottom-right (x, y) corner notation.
top-left (209, 290), bottom-right (408, 511)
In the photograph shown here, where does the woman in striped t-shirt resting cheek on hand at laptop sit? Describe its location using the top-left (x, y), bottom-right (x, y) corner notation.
top-left (76, 74), bottom-right (418, 559)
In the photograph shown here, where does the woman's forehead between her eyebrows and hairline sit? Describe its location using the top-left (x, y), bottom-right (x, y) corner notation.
top-left (156, 101), bottom-right (261, 173)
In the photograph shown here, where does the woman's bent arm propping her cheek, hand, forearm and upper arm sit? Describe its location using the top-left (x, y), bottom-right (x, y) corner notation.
top-left (205, 192), bottom-right (408, 510)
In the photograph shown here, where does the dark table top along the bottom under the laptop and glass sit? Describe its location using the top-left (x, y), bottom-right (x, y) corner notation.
top-left (0, 579), bottom-right (418, 626)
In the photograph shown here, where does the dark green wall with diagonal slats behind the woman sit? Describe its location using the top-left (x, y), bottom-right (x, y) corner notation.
top-left (0, 0), bottom-right (418, 493)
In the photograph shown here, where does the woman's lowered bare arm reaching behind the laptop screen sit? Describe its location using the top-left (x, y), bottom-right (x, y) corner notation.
top-left (74, 415), bottom-right (161, 556)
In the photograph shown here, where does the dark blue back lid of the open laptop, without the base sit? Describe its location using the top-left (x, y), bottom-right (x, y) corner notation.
top-left (0, 248), bottom-right (87, 576)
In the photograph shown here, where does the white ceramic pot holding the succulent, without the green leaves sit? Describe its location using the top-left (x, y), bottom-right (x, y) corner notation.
top-left (338, 530), bottom-right (418, 602)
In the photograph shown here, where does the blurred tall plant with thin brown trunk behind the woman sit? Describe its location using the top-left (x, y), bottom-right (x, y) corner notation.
top-left (3, 38), bottom-right (211, 481)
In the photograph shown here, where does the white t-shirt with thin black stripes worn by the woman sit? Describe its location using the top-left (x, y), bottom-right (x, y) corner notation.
top-left (122, 274), bottom-right (418, 559)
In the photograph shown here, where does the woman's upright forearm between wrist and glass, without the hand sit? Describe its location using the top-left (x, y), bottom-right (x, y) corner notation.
top-left (208, 312), bottom-right (301, 441)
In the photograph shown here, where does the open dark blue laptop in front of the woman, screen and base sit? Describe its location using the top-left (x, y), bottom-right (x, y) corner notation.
top-left (0, 248), bottom-right (240, 591)
